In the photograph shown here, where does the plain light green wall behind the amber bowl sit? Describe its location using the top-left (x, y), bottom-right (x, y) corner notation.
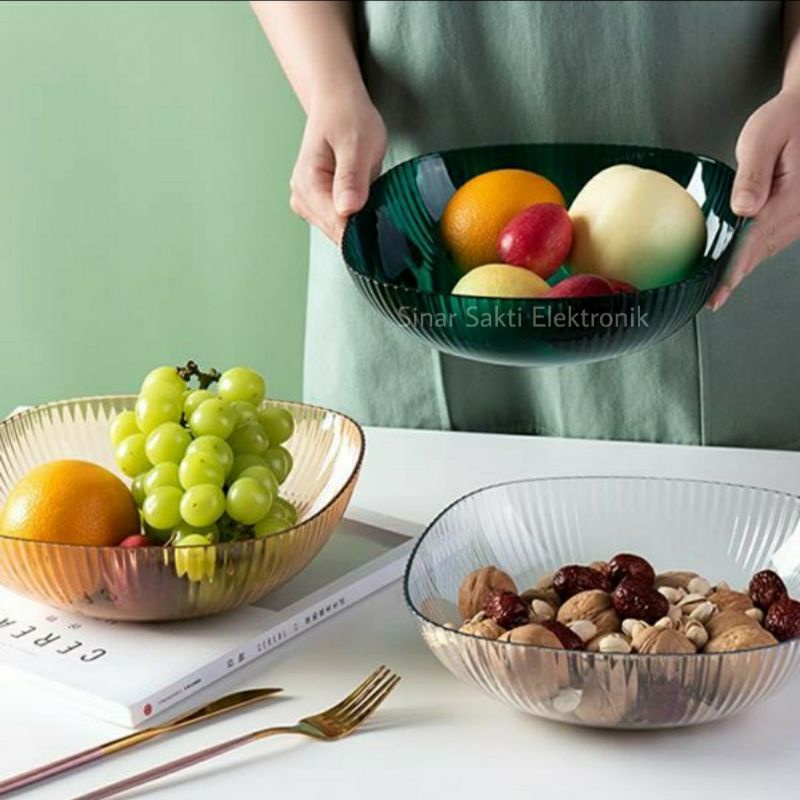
top-left (0, 2), bottom-right (307, 413)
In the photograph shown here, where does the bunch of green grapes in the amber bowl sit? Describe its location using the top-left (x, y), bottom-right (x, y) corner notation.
top-left (109, 361), bottom-right (297, 581)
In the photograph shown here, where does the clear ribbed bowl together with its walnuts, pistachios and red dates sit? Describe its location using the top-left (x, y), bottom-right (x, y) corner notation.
top-left (405, 477), bottom-right (800, 729)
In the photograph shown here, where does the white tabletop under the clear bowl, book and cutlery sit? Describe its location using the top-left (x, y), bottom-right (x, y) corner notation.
top-left (0, 429), bottom-right (800, 800)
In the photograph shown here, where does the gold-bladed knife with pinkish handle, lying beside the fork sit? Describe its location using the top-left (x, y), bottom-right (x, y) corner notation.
top-left (0, 689), bottom-right (282, 795)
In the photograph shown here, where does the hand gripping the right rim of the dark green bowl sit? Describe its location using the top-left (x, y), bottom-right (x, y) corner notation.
top-left (708, 90), bottom-right (800, 311)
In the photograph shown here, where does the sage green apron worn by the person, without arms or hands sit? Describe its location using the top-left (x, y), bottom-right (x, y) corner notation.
top-left (305, 0), bottom-right (800, 447)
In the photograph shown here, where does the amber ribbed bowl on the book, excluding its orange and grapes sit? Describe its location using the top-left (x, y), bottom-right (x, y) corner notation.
top-left (0, 396), bottom-right (364, 621)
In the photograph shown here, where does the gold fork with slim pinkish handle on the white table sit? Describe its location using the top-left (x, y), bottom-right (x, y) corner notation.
top-left (75, 666), bottom-right (400, 800)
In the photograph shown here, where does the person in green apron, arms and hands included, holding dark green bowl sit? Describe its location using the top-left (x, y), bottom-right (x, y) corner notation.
top-left (251, 0), bottom-right (800, 447)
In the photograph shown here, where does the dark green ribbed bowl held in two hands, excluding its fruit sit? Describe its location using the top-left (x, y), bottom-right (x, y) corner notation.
top-left (342, 144), bottom-right (741, 366)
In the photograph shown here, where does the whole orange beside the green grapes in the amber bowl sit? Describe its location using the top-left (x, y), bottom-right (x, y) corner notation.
top-left (0, 460), bottom-right (140, 547)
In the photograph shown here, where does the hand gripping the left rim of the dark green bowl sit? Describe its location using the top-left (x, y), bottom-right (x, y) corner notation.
top-left (290, 91), bottom-right (387, 244)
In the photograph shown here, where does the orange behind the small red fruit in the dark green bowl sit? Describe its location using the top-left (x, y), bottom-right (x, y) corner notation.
top-left (439, 169), bottom-right (566, 270)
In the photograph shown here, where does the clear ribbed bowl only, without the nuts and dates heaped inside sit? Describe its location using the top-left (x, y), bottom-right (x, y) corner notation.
top-left (405, 477), bottom-right (800, 728)
